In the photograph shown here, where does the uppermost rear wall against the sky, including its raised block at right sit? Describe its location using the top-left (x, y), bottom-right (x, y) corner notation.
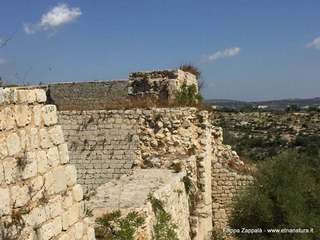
top-left (47, 70), bottom-right (197, 110)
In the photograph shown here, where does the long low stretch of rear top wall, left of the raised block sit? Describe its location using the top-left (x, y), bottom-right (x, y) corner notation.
top-left (47, 81), bottom-right (128, 110)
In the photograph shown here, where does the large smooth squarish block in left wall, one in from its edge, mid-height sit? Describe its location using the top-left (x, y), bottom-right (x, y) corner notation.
top-left (44, 167), bottom-right (67, 194)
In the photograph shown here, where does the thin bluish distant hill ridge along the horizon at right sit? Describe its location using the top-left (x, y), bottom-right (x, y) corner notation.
top-left (205, 97), bottom-right (320, 109)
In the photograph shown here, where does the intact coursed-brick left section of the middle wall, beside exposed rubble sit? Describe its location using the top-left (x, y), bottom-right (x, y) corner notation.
top-left (59, 110), bottom-right (138, 192)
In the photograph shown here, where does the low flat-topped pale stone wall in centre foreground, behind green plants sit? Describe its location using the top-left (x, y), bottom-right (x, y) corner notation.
top-left (87, 169), bottom-right (190, 240)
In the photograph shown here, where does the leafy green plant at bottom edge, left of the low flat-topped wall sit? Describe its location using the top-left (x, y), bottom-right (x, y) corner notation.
top-left (95, 211), bottom-right (145, 240)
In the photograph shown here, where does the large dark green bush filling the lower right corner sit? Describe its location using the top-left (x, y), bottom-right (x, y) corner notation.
top-left (230, 151), bottom-right (320, 240)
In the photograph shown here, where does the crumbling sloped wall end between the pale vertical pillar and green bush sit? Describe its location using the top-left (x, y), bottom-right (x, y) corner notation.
top-left (212, 127), bottom-right (253, 230)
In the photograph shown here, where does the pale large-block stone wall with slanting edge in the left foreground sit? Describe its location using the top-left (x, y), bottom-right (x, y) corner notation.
top-left (0, 88), bottom-right (95, 240)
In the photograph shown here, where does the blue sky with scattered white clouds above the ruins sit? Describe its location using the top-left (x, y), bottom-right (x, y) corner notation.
top-left (0, 0), bottom-right (320, 100)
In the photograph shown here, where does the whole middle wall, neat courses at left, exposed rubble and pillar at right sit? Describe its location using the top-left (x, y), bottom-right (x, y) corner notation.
top-left (59, 108), bottom-right (213, 239)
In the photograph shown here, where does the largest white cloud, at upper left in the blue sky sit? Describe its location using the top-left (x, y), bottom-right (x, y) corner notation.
top-left (24, 3), bottom-right (82, 34)
